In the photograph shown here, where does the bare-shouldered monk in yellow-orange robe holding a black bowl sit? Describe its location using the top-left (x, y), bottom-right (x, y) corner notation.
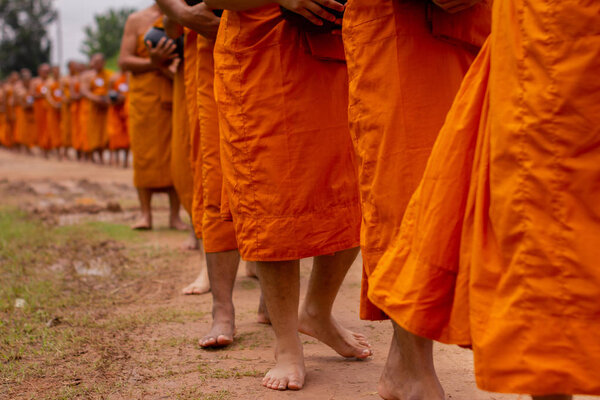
top-left (119, 4), bottom-right (188, 230)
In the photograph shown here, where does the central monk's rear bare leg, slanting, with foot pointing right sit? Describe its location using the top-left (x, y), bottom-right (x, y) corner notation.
top-left (299, 248), bottom-right (373, 359)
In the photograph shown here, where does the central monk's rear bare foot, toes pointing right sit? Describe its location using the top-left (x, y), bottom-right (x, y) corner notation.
top-left (298, 311), bottom-right (373, 360)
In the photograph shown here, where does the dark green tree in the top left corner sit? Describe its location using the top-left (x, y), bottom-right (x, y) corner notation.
top-left (0, 0), bottom-right (57, 76)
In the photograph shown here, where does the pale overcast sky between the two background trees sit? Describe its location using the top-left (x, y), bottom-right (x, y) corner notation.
top-left (50, 0), bottom-right (153, 67)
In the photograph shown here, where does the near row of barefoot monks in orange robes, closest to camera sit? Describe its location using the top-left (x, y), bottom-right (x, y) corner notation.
top-left (2, 0), bottom-right (600, 400)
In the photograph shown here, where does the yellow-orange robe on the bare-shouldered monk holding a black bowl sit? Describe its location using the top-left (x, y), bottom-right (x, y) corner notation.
top-left (129, 29), bottom-right (173, 188)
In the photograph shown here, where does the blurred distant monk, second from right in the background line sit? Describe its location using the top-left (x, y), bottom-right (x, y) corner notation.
top-left (81, 53), bottom-right (112, 164)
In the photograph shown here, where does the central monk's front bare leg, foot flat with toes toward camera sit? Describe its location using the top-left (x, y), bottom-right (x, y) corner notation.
top-left (256, 260), bottom-right (306, 390)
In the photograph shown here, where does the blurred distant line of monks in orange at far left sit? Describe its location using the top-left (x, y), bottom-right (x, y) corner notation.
top-left (0, 58), bottom-right (129, 167)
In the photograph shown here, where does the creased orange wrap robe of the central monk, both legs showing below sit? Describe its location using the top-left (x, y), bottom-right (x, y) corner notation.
top-left (213, 5), bottom-right (360, 261)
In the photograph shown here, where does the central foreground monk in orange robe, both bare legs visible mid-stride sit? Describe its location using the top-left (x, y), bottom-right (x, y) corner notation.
top-left (206, 0), bottom-right (371, 390)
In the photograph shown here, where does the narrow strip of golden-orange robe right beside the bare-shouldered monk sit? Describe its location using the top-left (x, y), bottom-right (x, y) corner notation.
top-left (171, 33), bottom-right (194, 215)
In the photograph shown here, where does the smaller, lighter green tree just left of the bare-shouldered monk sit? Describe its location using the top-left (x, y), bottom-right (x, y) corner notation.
top-left (81, 8), bottom-right (135, 58)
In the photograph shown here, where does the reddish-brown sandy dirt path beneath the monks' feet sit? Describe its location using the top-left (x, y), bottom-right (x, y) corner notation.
top-left (0, 150), bottom-right (592, 400)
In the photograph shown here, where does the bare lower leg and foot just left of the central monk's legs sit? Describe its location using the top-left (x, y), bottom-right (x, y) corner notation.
top-left (200, 250), bottom-right (240, 347)
